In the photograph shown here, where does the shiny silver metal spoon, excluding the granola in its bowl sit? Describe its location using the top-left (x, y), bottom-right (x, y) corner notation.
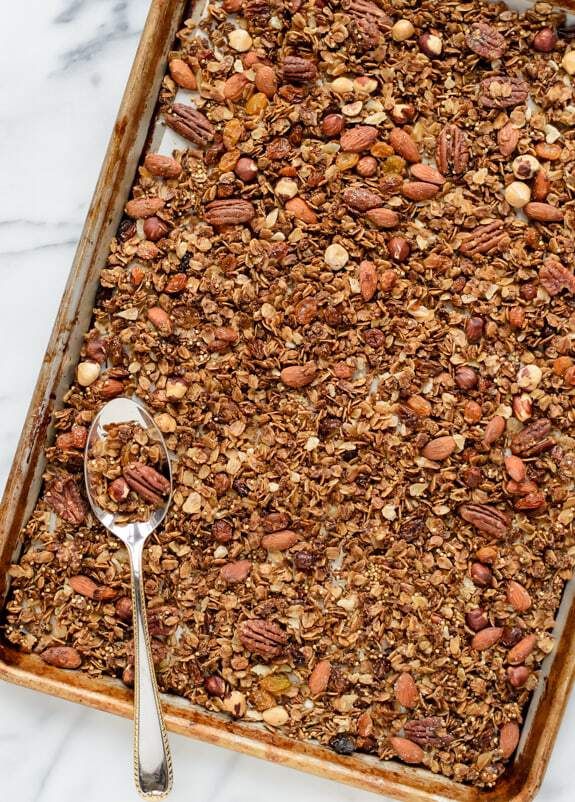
top-left (84, 398), bottom-right (173, 799)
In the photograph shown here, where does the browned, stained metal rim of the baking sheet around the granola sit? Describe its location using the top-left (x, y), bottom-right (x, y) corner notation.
top-left (0, 0), bottom-right (575, 802)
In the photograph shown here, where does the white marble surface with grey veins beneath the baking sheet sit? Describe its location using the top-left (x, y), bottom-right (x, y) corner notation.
top-left (0, 0), bottom-right (575, 802)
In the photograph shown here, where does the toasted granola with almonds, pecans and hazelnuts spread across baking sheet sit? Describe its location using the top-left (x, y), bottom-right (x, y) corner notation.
top-left (4, 0), bottom-right (575, 786)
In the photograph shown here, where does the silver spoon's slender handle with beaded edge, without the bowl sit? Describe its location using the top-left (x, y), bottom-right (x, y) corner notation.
top-left (128, 539), bottom-right (172, 799)
